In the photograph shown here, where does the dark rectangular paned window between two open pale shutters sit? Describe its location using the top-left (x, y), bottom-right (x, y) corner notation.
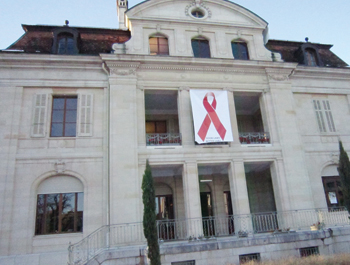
top-left (51, 97), bottom-right (78, 137)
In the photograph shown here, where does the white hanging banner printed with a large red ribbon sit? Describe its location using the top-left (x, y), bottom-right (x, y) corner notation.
top-left (190, 90), bottom-right (233, 144)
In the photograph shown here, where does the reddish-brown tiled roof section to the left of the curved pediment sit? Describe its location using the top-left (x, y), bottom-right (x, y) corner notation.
top-left (7, 25), bottom-right (130, 55)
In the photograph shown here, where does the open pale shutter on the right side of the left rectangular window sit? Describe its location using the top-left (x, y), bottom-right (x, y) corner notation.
top-left (77, 94), bottom-right (93, 136)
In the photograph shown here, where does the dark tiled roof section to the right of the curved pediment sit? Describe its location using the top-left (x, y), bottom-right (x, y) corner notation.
top-left (266, 40), bottom-right (348, 67)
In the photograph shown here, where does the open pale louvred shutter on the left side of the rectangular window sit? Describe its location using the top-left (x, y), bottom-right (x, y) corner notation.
top-left (31, 94), bottom-right (48, 137)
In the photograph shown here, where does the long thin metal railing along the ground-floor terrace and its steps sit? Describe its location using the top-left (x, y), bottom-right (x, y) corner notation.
top-left (69, 207), bottom-right (350, 265)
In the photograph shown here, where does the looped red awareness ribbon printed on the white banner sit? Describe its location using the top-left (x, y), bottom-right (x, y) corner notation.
top-left (198, 92), bottom-right (226, 141)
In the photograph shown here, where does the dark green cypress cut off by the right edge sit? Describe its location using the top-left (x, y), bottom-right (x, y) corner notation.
top-left (338, 141), bottom-right (350, 213)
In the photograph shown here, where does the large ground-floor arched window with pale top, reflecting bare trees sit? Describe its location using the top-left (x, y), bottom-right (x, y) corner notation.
top-left (35, 176), bottom-right (84, 235)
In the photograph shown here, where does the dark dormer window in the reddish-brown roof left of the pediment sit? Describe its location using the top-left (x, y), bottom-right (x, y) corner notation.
top-left (52, 26), bottom-right (79, 55)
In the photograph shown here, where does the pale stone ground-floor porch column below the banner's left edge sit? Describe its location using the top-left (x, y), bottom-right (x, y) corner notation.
top-left (182, 161), bottom-right (203, 237)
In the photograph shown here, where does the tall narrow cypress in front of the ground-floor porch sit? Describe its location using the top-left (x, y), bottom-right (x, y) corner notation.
top-left (142, 160), bottom-right (161, 265)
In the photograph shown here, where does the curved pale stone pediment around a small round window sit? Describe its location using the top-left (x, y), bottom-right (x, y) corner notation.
top-left (126, 0), bottom-right (267, 28)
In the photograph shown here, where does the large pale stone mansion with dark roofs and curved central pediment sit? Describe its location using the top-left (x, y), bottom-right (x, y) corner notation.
top-left (0, 0), bottom-right (350, 265)
